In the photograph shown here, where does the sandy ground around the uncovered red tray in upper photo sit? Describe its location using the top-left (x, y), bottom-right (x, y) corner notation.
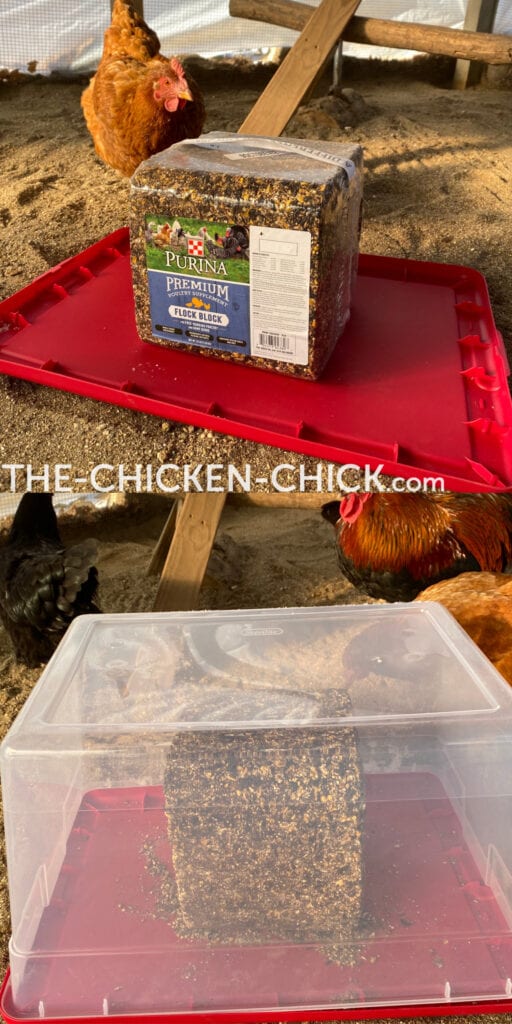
top-left (0, 60), bottom-right (512, 490)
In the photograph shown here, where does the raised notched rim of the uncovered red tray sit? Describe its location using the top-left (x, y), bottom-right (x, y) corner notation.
top-left (0, 227), bottom-right (512, 493)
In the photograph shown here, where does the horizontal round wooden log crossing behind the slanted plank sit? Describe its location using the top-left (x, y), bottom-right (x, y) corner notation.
top-left (229, 0), bottom-right (512, 65)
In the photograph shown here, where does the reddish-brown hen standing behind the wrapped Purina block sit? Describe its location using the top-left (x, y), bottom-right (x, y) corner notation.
top-left (82, 0), bottom-right (205, 175)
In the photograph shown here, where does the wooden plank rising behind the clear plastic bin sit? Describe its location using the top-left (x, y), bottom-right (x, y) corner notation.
top-left (154, 494), bottom-right (226, 611)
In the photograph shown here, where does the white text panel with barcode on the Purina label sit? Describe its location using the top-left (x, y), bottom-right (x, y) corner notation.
top-left (250, 226), bottom-right (311, 366)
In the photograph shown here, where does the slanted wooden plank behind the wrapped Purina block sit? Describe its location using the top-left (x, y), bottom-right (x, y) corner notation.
top-left (240, 0), bottom-right (359, 135)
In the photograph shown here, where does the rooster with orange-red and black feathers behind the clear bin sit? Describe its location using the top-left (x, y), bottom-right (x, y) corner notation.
top-left (322, 493), bottom-right (512, 601)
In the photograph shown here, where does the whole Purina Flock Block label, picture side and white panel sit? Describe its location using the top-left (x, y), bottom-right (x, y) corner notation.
top-left (145, 214), bottom-right (310, 366)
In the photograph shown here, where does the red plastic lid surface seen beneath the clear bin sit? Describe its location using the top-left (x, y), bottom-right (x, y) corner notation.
top-left (0, 773), bottom-right (512, 1022)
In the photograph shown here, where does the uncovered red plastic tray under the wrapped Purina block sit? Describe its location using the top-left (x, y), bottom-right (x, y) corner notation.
top-left (0, 228), bottom-right (512, 490)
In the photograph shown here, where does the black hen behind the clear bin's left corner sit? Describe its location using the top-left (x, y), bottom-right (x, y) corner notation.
top-left (0, 494), bottom-right (99, 668)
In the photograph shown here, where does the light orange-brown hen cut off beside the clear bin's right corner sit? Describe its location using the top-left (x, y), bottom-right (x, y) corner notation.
top-left (416, 572), bottom-right (512, 685)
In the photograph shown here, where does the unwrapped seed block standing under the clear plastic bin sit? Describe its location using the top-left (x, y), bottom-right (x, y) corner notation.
top-left (164, 690), bottom-right (364, 959)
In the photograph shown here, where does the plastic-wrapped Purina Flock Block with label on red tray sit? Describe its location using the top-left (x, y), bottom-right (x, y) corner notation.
top-left (131, 132), bottom-right (362, 379)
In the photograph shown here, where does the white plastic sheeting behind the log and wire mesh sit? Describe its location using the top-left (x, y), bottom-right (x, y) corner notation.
top-left (0, 0), bottom-right (512, 74)
